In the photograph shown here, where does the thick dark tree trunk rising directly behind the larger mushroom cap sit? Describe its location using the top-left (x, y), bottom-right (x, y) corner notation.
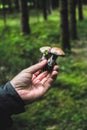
top-left (59, 0), bottom-right (71, 52)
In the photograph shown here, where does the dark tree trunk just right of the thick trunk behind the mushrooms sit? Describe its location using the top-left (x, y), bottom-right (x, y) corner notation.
top-left (69, 0), bottom-right (77, 40)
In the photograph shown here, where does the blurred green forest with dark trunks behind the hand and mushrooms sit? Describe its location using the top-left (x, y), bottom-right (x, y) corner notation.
top-left (0, 0), bottom-right (87, 130)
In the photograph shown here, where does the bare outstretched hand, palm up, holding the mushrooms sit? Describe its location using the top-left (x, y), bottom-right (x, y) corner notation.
top-left (10, 60), bottom-right (58, 103)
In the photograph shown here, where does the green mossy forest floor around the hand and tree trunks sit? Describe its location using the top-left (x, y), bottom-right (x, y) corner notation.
top-left (0, 7), bottom-right (87, 130)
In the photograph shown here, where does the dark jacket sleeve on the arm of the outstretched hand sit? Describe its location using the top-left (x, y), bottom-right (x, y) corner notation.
top-left (0, 82), bottom-right (25, 130)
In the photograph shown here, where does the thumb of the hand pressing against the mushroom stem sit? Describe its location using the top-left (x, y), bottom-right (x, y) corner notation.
top-left (27, 60), bottom-right (47, 74)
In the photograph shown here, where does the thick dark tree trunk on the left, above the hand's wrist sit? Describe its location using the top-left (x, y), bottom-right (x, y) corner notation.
top-left (19, 0), bottom-right (30, 34)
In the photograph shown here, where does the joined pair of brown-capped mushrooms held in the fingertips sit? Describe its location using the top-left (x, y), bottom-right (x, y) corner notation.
top-left (40, 46), bottom-right (65, 71)
